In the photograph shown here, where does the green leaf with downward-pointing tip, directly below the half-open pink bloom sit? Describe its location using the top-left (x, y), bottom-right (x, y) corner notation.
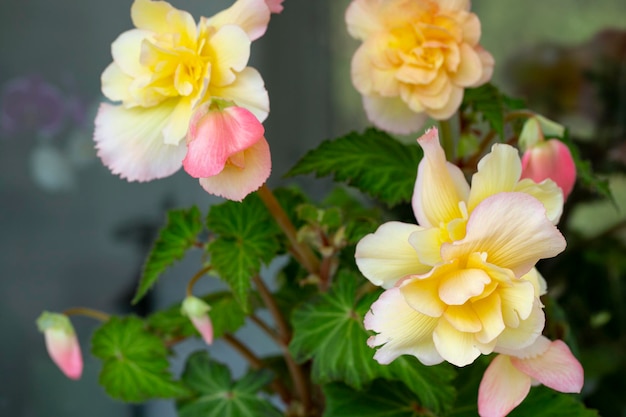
top-left (207, 194), bottom-right (280, 310)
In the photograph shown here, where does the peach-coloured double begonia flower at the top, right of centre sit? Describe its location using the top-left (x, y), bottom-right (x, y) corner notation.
top-left (346, 0), bottom-right (494, 134)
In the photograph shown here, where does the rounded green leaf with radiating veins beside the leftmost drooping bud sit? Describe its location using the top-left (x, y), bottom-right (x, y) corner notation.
top-left (91, 317), bottom-right (189, 402)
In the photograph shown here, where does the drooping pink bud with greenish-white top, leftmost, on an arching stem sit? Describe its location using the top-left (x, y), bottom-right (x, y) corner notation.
top-left (37, 311), bottom-right (83, 379)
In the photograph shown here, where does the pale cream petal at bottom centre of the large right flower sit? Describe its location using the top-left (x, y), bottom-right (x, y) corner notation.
top-left (433, 319), bottom-right (489, 366)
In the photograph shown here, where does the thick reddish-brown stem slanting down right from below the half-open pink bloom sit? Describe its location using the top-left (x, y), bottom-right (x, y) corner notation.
top-left (257, 184), bottom-right (319, 275)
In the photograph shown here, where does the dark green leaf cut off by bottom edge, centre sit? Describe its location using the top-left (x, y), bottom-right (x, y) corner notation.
top-left (323, 380), bottom-right (433, 417)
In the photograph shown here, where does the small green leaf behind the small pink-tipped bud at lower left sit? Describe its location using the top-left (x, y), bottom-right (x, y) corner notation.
top-left (147, 292), bottom-right (246, 340)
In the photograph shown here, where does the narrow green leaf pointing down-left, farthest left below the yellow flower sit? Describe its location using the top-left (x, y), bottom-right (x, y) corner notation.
top-left (132, 206), bottom-right (202, 304)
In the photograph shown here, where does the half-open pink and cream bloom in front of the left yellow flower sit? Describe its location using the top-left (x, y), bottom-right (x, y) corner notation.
top-left (183, 104), bottom-right (272, 201)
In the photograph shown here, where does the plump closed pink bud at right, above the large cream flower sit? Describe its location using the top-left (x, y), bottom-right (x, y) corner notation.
top-left (522, 139), bottom-right (576, 199)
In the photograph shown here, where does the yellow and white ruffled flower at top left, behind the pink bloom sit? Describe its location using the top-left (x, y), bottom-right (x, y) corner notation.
top-left (94, 0), bottom-right (270, 181)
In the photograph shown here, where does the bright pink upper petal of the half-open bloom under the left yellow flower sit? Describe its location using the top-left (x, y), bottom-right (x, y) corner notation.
top-left (183, 104), bottom-right (267, 178)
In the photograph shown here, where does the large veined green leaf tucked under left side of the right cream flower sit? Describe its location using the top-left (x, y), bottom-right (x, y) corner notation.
top-left (289, 272), bottom-right (455, 412)
